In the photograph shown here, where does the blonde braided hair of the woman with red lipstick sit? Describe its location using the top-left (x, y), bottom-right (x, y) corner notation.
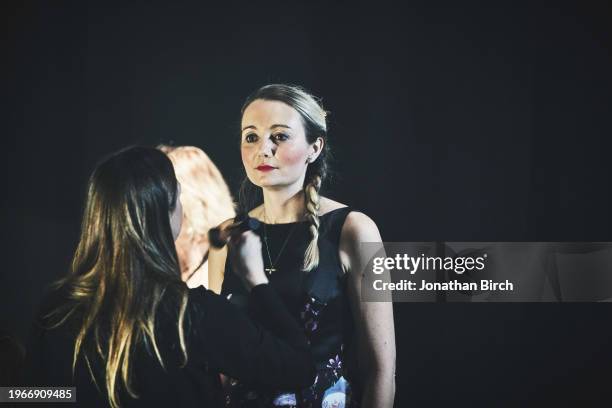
top-left (238, 84), bottom-right (331, 271)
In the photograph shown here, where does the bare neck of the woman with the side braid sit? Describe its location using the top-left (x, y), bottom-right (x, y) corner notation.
top-left (261, 184), bottom-right (306, 224)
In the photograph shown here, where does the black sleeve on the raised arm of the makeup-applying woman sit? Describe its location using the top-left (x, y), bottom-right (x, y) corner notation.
top-left (195, 285), bottom-right (315, 389)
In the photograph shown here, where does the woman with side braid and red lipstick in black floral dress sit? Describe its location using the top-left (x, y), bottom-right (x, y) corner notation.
top-left (209, 84), bottom-right (395, 408)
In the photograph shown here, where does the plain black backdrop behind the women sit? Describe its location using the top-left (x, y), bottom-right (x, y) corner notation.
top-left (0, 1), bottom-right (612, 407)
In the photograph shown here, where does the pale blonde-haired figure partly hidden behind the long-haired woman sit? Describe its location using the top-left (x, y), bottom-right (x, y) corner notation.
top-left (158, 145), bottom-right (236, 288)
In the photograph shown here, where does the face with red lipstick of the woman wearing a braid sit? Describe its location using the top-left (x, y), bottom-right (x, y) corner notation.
top-left (240, 99), bottom-right (323, 188)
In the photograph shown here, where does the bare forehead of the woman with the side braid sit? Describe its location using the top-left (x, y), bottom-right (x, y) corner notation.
top-left (242, 99), bottom-right (302, 129)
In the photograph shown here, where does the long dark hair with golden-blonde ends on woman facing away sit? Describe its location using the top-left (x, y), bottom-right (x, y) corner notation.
top-left (50, 147), bottom-right (187, 407)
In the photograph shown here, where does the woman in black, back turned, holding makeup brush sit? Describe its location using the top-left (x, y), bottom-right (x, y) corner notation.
top-left (27, 147), bottom-right (315, 407)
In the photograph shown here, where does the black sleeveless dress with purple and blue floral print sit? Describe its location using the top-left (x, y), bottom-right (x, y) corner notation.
top-left (221, 207), bottom-right (360, 408)
